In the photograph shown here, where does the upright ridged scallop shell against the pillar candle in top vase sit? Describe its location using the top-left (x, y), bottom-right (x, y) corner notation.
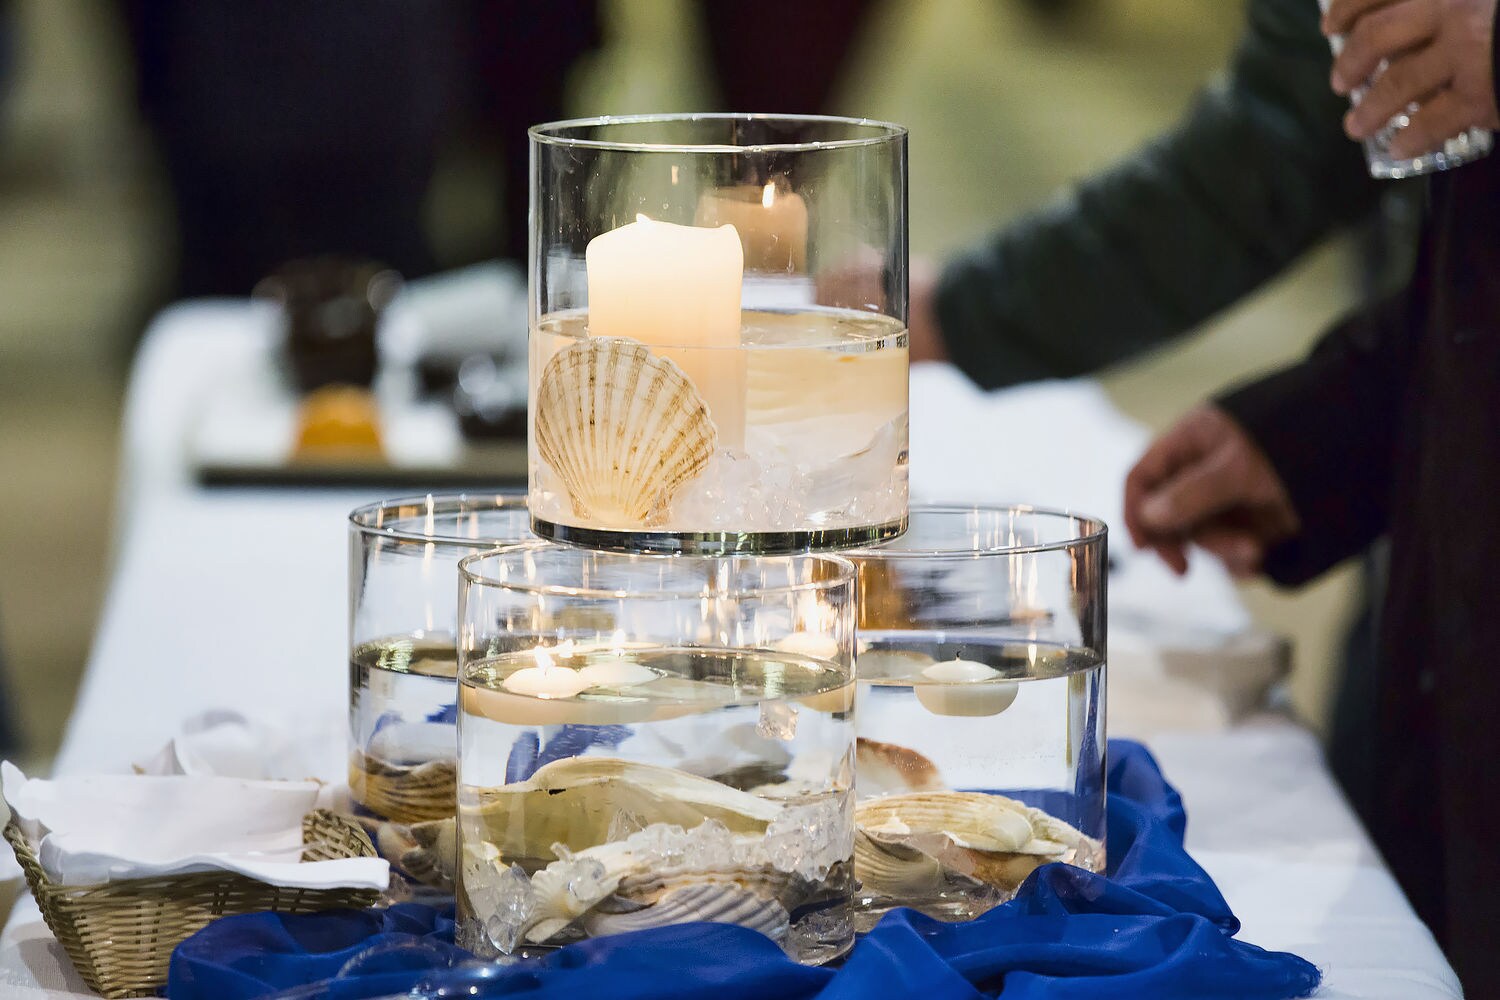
top-left (536, 337), bottom-right (719, 528)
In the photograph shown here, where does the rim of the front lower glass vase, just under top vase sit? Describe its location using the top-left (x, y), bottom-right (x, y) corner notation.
top-left (459, 538), bottom-right (857, 601)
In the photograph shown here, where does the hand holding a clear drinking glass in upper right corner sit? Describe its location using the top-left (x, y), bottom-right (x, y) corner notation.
top-left (1323, 0), bottom-right (1500, 157)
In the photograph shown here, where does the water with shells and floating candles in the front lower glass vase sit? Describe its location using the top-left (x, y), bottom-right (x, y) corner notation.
top-left (458, 646), bottom-right (855, 963)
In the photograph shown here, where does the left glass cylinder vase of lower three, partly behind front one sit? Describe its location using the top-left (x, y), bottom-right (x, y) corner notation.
top-left (350, 493), bottom-right (533, 898)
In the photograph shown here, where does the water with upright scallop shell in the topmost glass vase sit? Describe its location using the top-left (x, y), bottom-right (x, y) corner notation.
top-left (530, 309), bottom-right (908, 552)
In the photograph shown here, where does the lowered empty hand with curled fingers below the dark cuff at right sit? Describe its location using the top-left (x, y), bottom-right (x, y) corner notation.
top-left (1125, 405), bottom-right (1299, 577)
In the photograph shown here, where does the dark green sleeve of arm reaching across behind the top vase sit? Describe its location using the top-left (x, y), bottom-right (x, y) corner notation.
top-left (936, 0), bottom-right (1379, 388)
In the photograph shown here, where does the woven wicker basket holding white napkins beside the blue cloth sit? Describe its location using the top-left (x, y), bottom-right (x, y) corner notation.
top-left (5, 810), bottom-right (380, 997)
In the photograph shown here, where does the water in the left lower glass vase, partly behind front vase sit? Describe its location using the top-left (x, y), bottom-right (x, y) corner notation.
top-left (350, 634), bottom-right (458, 897)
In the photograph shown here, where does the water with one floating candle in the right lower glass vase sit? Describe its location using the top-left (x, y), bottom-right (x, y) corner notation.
top-left (855, 631), bottom-right (1104, 931)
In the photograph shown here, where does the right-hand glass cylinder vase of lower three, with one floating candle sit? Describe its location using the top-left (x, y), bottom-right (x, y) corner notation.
top-left (845, 505), bottom-right (1107, 931)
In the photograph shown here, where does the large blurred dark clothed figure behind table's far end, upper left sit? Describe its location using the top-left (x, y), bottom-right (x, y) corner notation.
top-left (122, 0), bottom-right (468, 297)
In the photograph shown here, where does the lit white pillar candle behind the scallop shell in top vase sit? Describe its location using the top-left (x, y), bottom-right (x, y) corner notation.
top-left (585, 216), bottom-right (746, 450)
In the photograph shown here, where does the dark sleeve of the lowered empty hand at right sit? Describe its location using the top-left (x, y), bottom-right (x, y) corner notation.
top-left (1215, 292), bottom-right (1421, 585)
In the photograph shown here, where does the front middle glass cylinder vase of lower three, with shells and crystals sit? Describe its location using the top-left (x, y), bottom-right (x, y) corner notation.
top-left (458, 543), bottom-right (855, 963)
